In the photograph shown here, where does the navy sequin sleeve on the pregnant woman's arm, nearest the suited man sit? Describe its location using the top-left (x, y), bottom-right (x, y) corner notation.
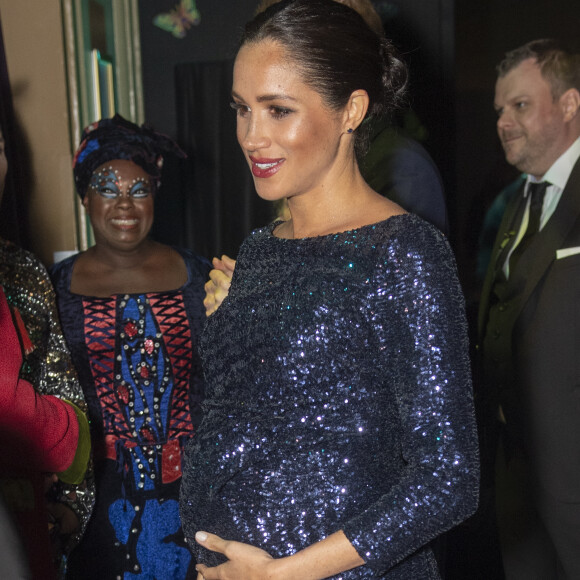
top-left (344, 222), bottom-right (479, 574)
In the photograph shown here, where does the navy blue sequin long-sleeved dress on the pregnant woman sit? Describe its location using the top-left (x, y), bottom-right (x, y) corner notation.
top-left (181, 214), bottom-right (479, 580)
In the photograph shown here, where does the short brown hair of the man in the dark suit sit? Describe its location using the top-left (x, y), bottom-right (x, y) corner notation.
top-left (496, 38), bottom-right (580, 100)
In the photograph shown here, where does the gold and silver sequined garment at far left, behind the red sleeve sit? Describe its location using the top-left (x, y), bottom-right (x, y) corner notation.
top-left (0, 239), bottom-right (95, 549)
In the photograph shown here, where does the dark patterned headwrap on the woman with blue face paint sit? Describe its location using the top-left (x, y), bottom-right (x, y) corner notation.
top-left (73, 115), bottom-right (185, 198)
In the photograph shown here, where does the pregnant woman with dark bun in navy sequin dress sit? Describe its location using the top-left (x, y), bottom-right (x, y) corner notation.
top-left (181, 0), bottom-right (479, 580)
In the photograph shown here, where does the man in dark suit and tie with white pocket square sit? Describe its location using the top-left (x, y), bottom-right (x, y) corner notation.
top-left (479, 40), bottom-right (580, 580)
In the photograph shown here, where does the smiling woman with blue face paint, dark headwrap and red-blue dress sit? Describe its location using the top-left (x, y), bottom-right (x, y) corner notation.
top-left (52, 116), bottom-right (209, 580)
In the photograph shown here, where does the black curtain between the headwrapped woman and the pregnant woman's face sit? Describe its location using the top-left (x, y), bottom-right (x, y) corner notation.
top-left (155, 61), bottom-right (273, 257)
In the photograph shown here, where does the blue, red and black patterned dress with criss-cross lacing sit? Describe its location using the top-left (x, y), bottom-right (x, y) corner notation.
top-left (52, 248), bottom-right (210, 580)
